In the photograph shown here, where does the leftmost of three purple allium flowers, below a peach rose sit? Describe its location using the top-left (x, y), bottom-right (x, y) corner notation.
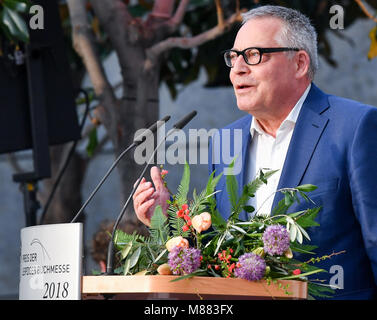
top-left (168, 247), bottom-right (201, 274)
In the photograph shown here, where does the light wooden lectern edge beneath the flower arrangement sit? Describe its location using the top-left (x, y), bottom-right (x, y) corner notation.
top-left (82, 275), bottom-right (307, 300)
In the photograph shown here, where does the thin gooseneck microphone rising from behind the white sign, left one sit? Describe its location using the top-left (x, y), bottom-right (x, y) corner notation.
top-left (71, 116), bottom-right (170, 223)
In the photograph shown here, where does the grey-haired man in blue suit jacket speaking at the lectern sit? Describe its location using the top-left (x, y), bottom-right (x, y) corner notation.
top-left (134, 6), bottom-right (377, 299)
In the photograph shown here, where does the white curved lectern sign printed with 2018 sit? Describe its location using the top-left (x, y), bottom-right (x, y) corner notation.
top-left (19, 223), bottom-right (83, 300)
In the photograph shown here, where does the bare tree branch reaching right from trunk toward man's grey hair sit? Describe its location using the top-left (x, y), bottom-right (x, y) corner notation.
top-left (144, 11), bottom-right (242, 70)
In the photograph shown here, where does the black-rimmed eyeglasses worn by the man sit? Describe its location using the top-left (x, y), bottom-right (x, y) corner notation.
top-left (224, 47), bottom-right (300, 68)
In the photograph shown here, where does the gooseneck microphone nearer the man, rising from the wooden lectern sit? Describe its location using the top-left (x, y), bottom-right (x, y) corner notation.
top-left (106, 111), bottom-right (197, 275)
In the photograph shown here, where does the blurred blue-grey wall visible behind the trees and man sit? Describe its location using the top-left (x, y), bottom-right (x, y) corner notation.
top-left (0, 20), bottom-right (377, 299)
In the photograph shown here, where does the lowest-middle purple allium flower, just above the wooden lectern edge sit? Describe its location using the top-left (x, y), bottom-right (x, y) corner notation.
top-left (234, 252), bottom-right (266, 281)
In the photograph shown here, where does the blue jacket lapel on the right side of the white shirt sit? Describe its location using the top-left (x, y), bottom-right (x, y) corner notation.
top-left (273, 83), bottom-right (329, 208)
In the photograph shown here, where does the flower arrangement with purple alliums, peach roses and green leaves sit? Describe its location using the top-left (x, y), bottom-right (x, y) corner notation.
top-left (114, 163), bottom-right (333, 298)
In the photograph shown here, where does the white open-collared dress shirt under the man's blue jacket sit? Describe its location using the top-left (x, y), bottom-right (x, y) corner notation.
top-left (246, 84), bottom-right (311, 215)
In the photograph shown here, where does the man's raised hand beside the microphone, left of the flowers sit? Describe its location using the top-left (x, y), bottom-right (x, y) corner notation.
top-left (132, 167), bottom-right (170, 227)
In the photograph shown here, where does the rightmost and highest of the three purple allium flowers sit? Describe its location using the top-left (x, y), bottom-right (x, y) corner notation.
top-left (262, 224), bottom-right (290, 256)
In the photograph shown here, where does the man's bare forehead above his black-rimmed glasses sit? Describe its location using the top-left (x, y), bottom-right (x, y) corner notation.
top-left (233, 17), bottom-right (283, 50)
